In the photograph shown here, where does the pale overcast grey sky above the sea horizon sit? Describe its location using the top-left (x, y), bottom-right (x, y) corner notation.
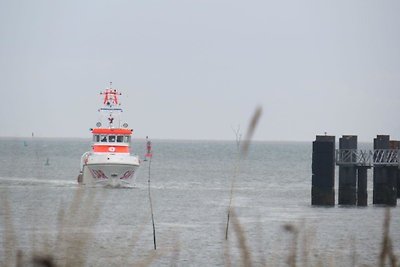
top-left (0, 0), bottom-right (400, 140)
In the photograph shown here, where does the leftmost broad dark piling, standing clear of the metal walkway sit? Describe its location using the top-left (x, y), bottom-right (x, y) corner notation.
top-left (311, 135), bottom-right (335, 206)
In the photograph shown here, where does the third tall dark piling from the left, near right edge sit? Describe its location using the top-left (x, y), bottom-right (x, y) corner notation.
top-left (373, 135), bottom-right (398, 206)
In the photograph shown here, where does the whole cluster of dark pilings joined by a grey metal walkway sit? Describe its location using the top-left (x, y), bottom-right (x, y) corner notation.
top-left (311, 135), bottom-right (400, 206)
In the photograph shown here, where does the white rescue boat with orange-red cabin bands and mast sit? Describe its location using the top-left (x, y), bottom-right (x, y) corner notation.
top-left (78, 83), bottom-right (140, 187)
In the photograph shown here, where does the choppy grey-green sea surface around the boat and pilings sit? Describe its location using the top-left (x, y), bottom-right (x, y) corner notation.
top-left (0, 137), bottom-right (400, 266)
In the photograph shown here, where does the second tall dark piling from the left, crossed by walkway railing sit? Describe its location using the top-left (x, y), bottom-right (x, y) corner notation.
top-left (338, 135), bottom-right (357, 205)
